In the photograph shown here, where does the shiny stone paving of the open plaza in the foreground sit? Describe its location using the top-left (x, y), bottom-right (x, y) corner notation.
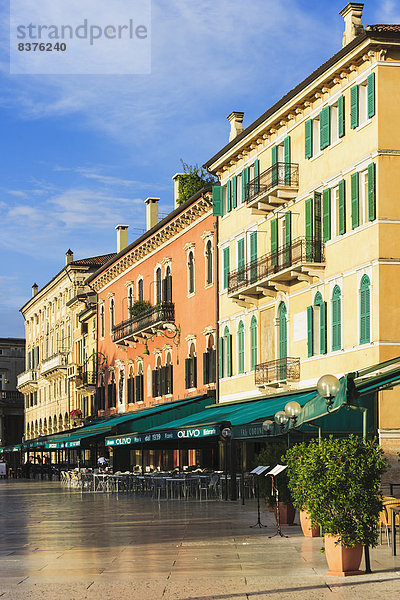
top-left (0, 480), bottom-right (400, 600)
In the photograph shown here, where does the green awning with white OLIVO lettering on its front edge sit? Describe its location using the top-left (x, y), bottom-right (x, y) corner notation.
top-left (106, 391), bottom-right (315, 446)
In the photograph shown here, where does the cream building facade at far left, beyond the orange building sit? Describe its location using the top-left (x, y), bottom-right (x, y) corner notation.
top-left (17, 250), bottom-right (113, 440)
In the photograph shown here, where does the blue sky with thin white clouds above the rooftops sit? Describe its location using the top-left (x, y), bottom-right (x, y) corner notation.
top-left (0, 0), bottom-right (400, 337)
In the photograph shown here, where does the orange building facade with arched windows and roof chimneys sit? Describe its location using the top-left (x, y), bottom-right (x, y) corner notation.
top-left (87, 188), bottom-right (217, 466)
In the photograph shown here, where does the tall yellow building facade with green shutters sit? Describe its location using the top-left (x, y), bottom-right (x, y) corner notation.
top-left (206, 3), bottom-right (400, 474)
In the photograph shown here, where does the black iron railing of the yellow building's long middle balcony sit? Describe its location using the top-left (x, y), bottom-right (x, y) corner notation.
top-left (228, 238), bottom-right (325, 294)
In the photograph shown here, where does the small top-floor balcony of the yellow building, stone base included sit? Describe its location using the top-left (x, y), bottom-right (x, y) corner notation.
top-left (246, 162), bottom-right (299, 214)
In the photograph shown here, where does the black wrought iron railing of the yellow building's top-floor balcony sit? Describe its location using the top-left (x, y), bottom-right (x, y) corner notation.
top-left (246, 162), bottom-right (299, 204)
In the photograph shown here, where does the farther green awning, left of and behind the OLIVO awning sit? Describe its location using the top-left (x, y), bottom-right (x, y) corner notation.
top-left (46, 395), bottom-right (211, 450)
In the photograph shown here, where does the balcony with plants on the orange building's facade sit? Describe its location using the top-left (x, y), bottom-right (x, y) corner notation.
top-left (113, 302), bottom-right (175, 343)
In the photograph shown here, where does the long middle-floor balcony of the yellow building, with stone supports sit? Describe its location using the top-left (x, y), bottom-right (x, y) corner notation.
top-left (228, 238), bottom-right (325, 303)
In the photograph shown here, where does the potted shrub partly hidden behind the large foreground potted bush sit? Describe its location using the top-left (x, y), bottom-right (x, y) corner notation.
top-left (284, 442), bottom-right (321, 537)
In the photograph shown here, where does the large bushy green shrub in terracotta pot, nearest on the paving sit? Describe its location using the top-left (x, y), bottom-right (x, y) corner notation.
top-left (289, 436), bottom-right (387, 576)
